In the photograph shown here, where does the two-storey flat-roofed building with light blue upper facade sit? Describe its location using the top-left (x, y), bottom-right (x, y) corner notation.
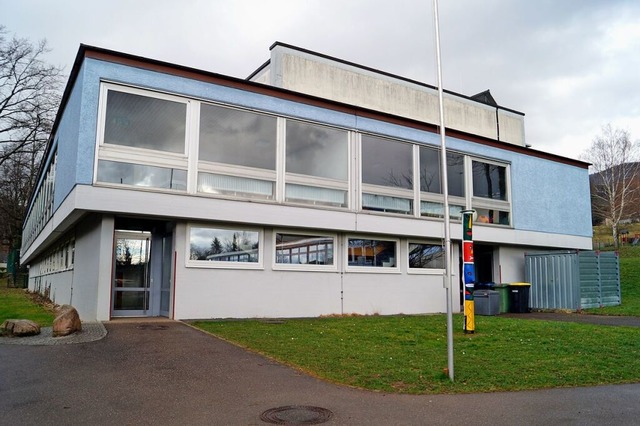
top-left (21, 43), bottom-right (591, 320)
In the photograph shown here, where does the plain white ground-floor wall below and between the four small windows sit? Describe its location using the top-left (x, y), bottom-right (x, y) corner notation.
top-left (174, 223), bottom-right (450, 319)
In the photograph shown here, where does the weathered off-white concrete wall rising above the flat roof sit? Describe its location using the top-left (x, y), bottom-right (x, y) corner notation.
top-left (252, 45), bottom-right (525, 146)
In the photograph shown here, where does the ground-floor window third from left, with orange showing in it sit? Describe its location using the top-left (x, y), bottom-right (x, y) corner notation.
top-left (347, 238), bottom-right (398, 269)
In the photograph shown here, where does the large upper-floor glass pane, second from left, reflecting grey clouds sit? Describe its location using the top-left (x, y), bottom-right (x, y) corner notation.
top-left (199, 104), bottom-right (277, 170)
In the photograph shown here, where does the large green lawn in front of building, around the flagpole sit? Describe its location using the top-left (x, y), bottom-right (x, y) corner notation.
top-left (193, 315), bottom-right (640, 394)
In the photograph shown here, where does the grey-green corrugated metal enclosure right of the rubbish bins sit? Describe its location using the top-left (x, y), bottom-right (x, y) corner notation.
top-left (525, 251), bottom-right (622, 310)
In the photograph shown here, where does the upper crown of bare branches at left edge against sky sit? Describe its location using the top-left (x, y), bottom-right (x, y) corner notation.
top-left (0, 26), bottom-right (62, 166)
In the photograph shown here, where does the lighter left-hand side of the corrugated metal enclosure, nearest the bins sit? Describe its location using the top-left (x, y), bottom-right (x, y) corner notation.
top-left (525, 252), bottom-right (580, 309)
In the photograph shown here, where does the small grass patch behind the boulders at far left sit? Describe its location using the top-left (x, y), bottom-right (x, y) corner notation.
top-left (0, 280), bottom-right (54, 327)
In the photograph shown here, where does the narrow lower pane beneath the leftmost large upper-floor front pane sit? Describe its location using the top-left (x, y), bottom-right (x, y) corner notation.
top-left (97, 160), bottom-right (187, 191)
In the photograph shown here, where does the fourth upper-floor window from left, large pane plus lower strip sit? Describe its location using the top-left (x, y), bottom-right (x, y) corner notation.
top-left (361, 135), bottom-right (414, 214)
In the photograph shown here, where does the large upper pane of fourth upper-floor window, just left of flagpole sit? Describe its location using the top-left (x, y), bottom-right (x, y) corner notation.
top-left (362, 135), bottom-right (413, 189)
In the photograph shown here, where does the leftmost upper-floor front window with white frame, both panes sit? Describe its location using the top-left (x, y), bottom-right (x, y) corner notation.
top-left (94, 84), bottom-right (190, 191)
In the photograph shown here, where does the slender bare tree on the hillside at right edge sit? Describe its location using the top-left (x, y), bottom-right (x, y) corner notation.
top-left (584, 124), bottom-right (640, 248)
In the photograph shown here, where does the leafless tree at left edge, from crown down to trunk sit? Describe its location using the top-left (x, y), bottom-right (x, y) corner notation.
top-left (0, 26), bottom-right (62, 247)
